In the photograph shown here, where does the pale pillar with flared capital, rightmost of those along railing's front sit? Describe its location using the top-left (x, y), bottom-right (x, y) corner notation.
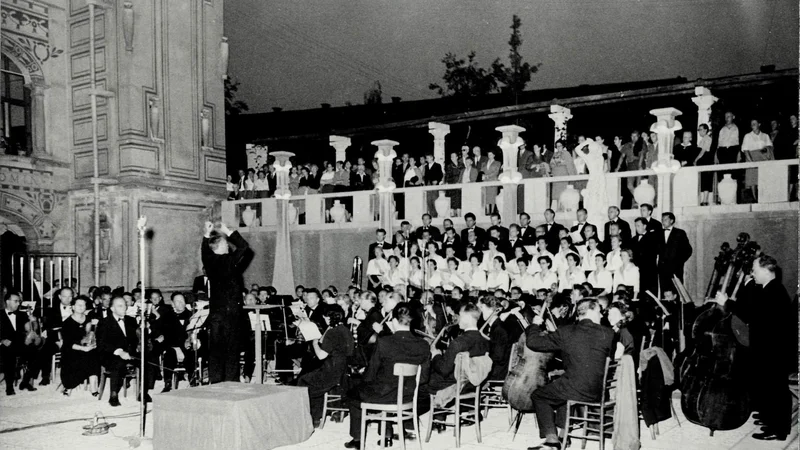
top-left (650, 108), bottom-right (683, 213)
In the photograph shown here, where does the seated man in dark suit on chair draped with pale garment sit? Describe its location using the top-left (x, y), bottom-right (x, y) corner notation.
top-left (423, 303), bottom-right (491, 397)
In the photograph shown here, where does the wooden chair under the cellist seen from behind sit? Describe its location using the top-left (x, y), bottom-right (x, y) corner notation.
top-left (561, 358), bottom-right (619, 450)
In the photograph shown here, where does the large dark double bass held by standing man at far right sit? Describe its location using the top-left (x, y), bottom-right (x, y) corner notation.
top-left (674, 239), bottom-right (759, 436)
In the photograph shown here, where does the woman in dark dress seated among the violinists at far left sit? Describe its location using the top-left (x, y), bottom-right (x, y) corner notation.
top-left (61, 296), bottom-right (100, 396)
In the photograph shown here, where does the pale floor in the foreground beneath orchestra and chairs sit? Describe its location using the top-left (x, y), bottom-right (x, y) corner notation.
top-left (0, 385), bottom-right (799, 450)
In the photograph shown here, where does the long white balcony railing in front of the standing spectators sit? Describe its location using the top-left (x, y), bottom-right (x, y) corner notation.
top-left (222, 159), bottom-right (798, 231)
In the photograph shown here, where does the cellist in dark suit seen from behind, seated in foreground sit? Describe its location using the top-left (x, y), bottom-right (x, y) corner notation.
top-left (525, 298), bottom-right (614, 449)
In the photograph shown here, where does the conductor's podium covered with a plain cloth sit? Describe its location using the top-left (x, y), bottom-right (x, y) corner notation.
top-left (153, 382), bottom-right (314, 450)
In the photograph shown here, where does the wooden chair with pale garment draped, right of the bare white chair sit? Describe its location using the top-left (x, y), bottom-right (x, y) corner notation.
top-left (425, 352), bottom-right (481, 448)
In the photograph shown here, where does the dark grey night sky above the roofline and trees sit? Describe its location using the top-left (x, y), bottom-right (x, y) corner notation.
top-left (225, 0), bottom-right (798, 112)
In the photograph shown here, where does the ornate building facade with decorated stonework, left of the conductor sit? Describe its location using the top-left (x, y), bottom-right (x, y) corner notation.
top-left (0, 0), bottom-right (227, 288)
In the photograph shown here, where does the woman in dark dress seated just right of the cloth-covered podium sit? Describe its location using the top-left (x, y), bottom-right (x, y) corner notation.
top-left (297, 305), bottom-right (355, 427)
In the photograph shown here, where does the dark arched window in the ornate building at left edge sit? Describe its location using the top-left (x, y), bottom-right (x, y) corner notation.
top-left (0, 55), bottom-right (33, 156)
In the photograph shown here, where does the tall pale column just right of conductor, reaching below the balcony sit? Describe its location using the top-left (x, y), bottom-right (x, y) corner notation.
top-left (270, 152), bottom-right (295, 294)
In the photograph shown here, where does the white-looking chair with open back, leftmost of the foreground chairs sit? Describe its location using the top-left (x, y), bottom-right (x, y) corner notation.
top-left (361, 363), bottom-right (422, 450)
